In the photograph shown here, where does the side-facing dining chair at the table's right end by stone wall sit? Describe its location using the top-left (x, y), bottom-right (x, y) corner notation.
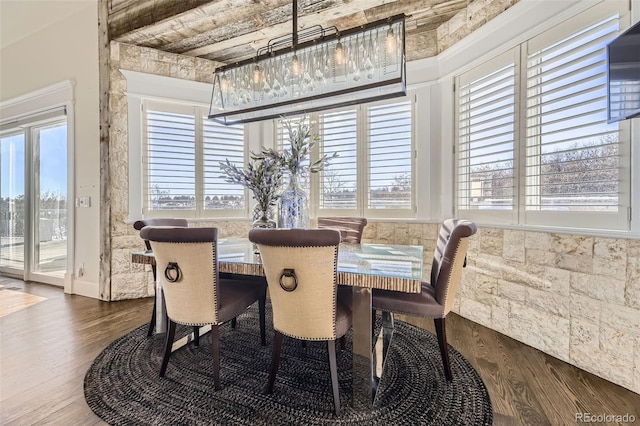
top-left (371, 219), bottom-right (477, 381)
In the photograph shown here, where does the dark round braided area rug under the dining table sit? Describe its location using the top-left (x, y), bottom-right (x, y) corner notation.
top-left (84, 303), bottom-right (493, 426)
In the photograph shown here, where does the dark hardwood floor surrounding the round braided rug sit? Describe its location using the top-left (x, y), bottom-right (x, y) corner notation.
top-left (0, 276), bottom-right (640, 426)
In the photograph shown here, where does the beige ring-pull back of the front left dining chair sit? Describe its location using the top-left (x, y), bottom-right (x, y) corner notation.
top-left (140, 226), bottom-right (219, 325)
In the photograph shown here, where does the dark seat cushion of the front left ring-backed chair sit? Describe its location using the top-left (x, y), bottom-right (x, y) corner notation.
top-left (218, 279), bottom-right (266, 323)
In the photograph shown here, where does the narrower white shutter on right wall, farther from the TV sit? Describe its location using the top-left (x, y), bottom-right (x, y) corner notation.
top-left (456, 49), bottom-right (517, 221)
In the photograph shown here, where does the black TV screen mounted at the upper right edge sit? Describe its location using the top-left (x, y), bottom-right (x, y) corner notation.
top-left (607, 22), bottom-right (640, 123)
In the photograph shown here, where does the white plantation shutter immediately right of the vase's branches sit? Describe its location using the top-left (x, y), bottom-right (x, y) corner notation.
top-left (319, 108), bottom-right (358, 213)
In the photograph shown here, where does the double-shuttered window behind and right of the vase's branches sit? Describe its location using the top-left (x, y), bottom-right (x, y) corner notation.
top-left (276, 99), bottom-right (416, 217)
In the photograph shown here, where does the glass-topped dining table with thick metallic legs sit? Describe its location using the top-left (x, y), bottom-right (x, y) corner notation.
top-left (131, 238), bottom-right (424, 410)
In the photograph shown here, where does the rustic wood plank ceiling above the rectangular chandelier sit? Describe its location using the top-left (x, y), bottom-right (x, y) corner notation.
top-left (109, 0), bottom-right (471, 64)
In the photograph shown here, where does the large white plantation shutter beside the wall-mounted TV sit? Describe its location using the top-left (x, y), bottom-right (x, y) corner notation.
top-left (526, 15), bottom-right (620, 223)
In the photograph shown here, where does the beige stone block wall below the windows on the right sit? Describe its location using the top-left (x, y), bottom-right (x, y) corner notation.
top-left (363, 223), bottom-right (640, 393)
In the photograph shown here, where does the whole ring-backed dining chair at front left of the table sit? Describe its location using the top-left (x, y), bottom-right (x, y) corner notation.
top-left (141, 226), bottom-right (266, 390)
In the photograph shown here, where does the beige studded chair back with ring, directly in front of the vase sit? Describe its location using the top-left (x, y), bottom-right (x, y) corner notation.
top-left (249, 228), bottom-right (340, 340)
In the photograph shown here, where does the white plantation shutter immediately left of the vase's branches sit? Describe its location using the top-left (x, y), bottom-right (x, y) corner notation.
top-left (202, 118), bottom-right (246, 210)
